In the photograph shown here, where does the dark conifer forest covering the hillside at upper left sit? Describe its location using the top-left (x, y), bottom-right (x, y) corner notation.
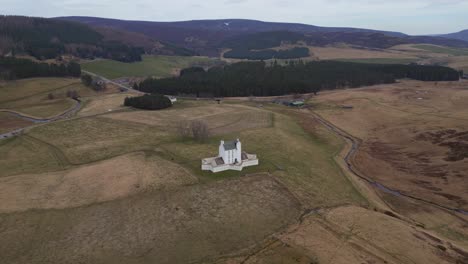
top-left (0, 16), bottom-right (145, 62)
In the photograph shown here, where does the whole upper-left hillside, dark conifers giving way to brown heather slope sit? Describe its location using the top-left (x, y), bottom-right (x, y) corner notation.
top-left (0, 16), bottom-right (194, 62)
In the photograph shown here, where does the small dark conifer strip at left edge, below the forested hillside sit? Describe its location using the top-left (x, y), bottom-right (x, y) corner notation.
top-left (0, 57), bottom-right (81, 80)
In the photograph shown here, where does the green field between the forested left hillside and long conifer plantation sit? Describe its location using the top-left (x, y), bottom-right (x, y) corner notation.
top-left (81, 55), bottom-right (221, 79)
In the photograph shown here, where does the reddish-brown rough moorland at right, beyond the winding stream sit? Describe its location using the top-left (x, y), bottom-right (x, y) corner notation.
top-left (312, 81), bottom-right (468, 245)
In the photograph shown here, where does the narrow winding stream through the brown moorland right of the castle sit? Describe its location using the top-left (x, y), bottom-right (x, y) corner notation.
top-left (310, 111), bottom-right (468, 215)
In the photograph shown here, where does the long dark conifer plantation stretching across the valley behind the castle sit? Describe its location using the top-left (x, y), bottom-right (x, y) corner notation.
top-left (134, 61), bottom-right (459, 97)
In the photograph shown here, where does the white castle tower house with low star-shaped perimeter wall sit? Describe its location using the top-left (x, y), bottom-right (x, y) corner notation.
top-left (202, 139), bottom-right (258, 172)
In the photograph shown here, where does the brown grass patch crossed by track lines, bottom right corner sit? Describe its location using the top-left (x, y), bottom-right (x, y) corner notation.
top-left (272, 206), bottom-right (466, 264)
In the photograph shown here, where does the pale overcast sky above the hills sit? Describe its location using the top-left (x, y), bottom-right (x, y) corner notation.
top-left (0, 0), bottom-right (468, 34)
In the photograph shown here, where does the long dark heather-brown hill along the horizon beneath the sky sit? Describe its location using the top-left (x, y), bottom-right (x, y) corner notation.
top-left (57, 17), bottom-right (468, 56)
